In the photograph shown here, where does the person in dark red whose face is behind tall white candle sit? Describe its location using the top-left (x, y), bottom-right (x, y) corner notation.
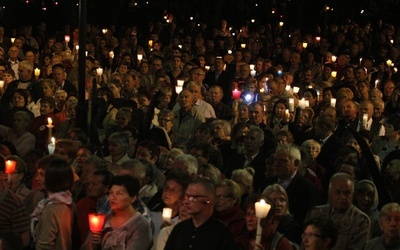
top-left (235, 194), bottom-right (294, 250)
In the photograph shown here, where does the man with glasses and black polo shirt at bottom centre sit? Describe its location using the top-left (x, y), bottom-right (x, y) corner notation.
top-left (165, 179), bottom-right (237, 250)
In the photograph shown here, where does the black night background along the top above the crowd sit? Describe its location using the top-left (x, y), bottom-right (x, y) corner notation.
top-left (0, 0), bottom-right (400, 35)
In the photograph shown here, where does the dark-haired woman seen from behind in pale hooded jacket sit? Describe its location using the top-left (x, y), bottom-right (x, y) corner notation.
top-left (31, 158), bottom-right (77, 249)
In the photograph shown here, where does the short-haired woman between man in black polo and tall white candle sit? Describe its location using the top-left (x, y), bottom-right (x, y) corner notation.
top-left (214, 179), bottom-right (246, 238)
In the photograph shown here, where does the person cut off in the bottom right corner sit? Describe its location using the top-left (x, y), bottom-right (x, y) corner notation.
top-left (364, 203), bottom-right (400, 250)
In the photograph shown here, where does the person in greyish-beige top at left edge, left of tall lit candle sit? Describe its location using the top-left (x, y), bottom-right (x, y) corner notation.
top-left (0, 111), bottom-right (36, 157)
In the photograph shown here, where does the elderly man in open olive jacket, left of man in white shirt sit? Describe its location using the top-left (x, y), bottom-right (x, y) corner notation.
top-left (171, 89), bottom-right (205, 147)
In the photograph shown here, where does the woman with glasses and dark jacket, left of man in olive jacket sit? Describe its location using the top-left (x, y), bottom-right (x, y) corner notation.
top-left (149, 109), bottom-right (175, 149)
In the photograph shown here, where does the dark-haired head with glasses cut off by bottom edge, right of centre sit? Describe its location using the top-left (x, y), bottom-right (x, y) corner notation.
top-left (301, 218), bottom-right (338, 250)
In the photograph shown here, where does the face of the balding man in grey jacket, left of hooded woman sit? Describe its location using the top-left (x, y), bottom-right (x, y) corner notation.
top-left (328, 180), bottom-right (354, 212)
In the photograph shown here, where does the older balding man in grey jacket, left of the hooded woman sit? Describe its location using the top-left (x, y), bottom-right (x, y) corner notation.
top-left (308, 173), bottom-right (370, 250)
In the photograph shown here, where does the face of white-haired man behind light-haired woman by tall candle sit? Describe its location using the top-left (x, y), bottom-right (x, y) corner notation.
top-left (274, 149), bottom-right (299, 180)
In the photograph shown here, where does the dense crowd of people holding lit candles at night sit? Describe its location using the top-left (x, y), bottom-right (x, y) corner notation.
top-left (0, 16), bottom-right (400, 250)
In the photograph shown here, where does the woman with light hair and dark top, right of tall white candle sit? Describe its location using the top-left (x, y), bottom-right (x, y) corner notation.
top-left (263, 184), bottom-right (301, 244)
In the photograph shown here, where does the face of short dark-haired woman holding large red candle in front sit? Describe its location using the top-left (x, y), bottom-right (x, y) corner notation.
top-left (108, 185), bottom-right (136, 212)
